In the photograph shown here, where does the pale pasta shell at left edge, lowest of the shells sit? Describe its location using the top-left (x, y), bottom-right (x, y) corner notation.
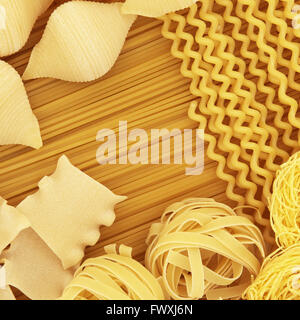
top-left (0, 61), bottom-right (43, 149)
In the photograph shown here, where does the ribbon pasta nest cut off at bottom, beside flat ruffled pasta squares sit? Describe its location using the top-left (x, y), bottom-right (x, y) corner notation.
top-left (60, 245), bottom-right (164, 300)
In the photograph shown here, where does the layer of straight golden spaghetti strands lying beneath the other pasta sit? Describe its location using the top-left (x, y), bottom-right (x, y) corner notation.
top-left (0, 0), bottom-right (230, 298)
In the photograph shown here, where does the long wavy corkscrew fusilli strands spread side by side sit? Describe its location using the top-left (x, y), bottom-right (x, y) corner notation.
top-left (160, 0), bottom-right (300, 243)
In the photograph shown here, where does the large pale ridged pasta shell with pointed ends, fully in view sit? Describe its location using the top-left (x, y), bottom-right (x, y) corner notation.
top-left (23, 1), bottom-right (136, 82)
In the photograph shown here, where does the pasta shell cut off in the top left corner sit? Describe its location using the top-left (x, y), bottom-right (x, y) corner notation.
top-left (0, 0), bottom-right (53, 57)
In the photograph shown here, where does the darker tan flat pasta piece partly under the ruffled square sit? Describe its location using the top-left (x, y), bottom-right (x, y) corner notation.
top-left (4, 228), bottom-right (75, 300)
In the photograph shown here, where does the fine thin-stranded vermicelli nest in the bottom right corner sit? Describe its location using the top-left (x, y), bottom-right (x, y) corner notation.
top-left (244, 244), bottom-right (300, 300)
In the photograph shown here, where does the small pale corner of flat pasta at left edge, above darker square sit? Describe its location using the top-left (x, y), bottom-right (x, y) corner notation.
top-left (0, 197), bottom-right (30, 255)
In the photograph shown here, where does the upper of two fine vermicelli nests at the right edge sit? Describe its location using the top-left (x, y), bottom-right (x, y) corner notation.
top-left (270, 152), bottom-right (300, 247)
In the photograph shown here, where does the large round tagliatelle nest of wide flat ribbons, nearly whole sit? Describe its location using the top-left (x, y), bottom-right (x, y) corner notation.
top-left (145, 198), bottom-right (265, 300)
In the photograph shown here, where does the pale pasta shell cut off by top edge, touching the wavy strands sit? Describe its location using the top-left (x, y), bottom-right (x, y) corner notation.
top-left (122, 0), bottom-right (198, 18)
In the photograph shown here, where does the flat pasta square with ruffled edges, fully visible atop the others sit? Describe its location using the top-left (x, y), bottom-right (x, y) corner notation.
top-left (17, 156), bottom-right (126, 269)
